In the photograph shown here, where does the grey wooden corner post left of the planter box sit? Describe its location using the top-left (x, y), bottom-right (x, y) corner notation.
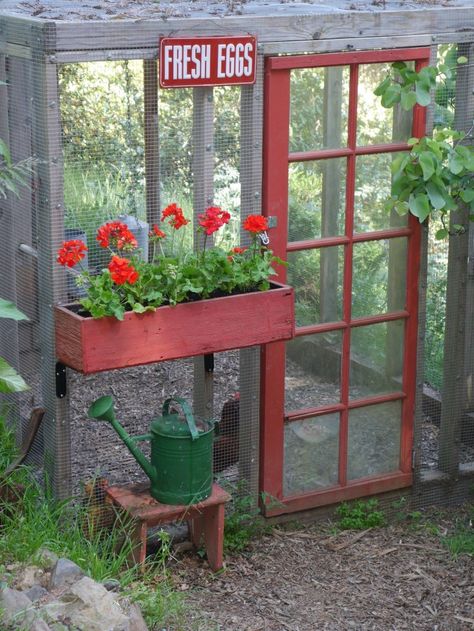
top-left (33, 48), bottom-right (72, 498)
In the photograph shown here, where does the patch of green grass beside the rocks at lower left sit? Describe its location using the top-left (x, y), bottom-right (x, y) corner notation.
top-left (0, 416), bottom-right (186, 631)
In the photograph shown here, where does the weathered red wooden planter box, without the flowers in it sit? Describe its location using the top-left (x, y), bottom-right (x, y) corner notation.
top-left (55, 283), bottom-right (295, 374)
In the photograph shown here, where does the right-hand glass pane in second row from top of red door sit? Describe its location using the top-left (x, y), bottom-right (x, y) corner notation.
top-left (354, 153), bottom-right (408, 232)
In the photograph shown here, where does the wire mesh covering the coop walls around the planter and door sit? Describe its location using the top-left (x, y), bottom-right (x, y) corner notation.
top-left (0, 11), bottom-right (474, 524)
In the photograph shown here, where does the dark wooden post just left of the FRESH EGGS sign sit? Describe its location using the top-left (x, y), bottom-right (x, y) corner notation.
top-left (143, 59), bottom-right (160, 239)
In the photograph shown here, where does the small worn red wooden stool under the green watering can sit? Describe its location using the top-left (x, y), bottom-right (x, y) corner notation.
top-left (107, 483), bottom-right (231, 572)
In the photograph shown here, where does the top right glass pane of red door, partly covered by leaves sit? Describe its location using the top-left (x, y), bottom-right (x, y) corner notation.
top-left (357, 64), bottom-right (412, 146)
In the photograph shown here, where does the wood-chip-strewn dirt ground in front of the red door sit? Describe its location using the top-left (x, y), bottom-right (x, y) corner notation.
top-left (175, 518), bottom-right (474, 631)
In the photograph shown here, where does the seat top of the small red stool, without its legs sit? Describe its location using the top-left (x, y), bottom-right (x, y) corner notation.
top-left (107, 482), bottom-right (231, 522)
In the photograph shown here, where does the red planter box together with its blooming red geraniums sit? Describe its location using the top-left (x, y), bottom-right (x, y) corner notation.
top-left (56, 204), bottom-right (295, 373)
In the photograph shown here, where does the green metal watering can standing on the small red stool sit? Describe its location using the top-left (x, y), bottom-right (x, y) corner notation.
top-left (88, 396), bottom-right (216, 504)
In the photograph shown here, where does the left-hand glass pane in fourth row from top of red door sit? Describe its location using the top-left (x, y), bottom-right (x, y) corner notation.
top-left (285, 331), bottom-right (342, 412)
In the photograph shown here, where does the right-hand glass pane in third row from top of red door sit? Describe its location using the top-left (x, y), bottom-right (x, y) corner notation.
top-left (352, 237), bottom-right (407, 318)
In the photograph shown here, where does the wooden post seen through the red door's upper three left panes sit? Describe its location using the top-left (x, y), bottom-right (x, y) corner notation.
top-left (319, 67), bottom-right (343, 322)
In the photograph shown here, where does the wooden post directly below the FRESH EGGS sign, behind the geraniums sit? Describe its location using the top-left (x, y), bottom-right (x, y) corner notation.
top-left (193, 88), bottom-right (214, 418)
